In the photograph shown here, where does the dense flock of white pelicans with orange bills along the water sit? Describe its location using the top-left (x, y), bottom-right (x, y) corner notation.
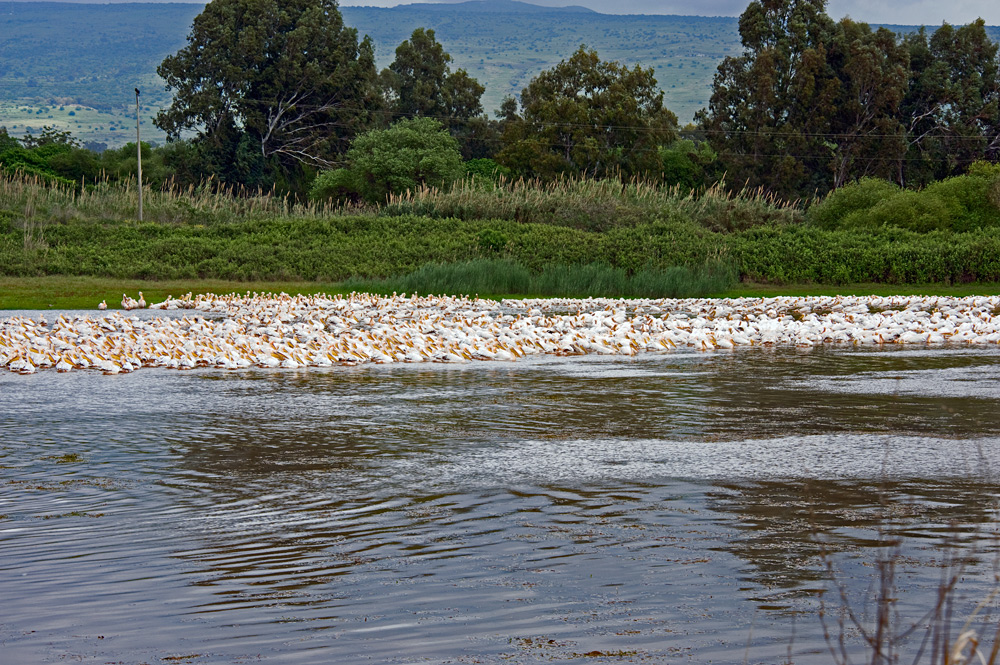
top-left (0, 293), bottom-right (1000, 374)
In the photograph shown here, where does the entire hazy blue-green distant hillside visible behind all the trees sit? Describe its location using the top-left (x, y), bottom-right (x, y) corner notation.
top-left (0, 0), bottom-right (1000, 146)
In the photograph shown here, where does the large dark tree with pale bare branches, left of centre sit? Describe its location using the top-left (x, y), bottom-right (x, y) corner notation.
top-left (155, 0), bottom-right (379, 172)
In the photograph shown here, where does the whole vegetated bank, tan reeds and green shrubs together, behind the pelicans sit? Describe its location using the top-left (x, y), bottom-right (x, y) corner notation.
top-left (0, 172), bottom-right (1000, 296)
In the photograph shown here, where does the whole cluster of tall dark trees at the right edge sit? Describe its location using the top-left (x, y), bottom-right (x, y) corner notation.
top-left (698, 0), bottom-right (1000, 197)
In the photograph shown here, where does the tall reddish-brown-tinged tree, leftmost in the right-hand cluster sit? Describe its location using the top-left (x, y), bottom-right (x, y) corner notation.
top-left (698, 0), bottom-right (840, 197)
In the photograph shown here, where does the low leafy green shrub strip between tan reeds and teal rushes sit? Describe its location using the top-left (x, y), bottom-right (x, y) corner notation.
top-left (7, 216), bottom-right (1000, 285)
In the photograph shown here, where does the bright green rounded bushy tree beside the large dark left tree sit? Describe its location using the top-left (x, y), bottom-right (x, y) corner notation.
top-left (310, 118), bottom-right (464, 203)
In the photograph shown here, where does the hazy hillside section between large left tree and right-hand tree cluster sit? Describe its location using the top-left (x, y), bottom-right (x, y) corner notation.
top-left (341, 1), bottom-right (740, 121)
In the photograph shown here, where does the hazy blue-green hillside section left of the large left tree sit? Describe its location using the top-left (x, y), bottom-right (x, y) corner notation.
top-left (0, 2), bottom-right (203, 146)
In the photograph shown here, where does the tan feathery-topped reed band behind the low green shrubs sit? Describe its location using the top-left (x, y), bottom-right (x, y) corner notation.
top-left (0, 172), bottom-right (803, 239)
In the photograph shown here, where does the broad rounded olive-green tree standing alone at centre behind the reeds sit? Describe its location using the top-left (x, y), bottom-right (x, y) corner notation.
top-left (497, 46), bottom-right (677, 178)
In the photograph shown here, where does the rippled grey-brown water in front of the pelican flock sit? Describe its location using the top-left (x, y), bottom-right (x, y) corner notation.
top-left (0, 348), bottom-right (1000, 664)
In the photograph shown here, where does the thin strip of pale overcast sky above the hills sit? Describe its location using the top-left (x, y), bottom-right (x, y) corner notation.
top-left (340, 0), bottom-right (1000, 26)
